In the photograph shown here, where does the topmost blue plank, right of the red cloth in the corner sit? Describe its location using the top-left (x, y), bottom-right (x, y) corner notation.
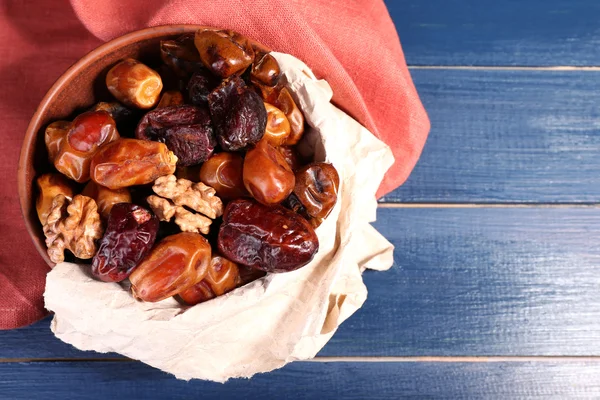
top-left (385, 0), bottom-right (600, 66)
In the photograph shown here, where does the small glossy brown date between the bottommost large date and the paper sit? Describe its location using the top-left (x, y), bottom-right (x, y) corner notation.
top-left (179, 256), bottom-right (241, 306)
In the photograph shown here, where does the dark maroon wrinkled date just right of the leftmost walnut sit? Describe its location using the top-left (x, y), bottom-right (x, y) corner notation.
top-left (92, 203), bottom-right (159, 282)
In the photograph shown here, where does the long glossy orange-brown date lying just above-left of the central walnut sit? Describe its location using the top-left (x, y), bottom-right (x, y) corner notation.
top-left (90, 139), bottom-right (177, 189)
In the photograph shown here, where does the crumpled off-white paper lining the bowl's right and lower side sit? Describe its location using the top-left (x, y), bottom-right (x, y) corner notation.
top-left (44, 53), bottom-right (393, 382)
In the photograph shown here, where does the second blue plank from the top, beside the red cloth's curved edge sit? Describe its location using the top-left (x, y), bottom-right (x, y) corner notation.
top-left (383, 69), bottom-right (600, 203)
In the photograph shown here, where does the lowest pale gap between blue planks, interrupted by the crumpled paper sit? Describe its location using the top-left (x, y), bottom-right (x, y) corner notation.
top-left (0, 356), bottom-right (600, 364)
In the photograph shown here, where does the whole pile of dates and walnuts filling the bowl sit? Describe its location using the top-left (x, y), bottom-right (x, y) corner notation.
top-left (36, 29), bottom-right (339, 305)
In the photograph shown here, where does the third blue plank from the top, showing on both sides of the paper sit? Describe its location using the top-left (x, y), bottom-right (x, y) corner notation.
top-left (0, 208), bottom-right (600, 358)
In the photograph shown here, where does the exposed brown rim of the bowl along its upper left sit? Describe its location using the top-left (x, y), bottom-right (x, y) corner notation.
top-left (17, 24), bottom-right (209, 267)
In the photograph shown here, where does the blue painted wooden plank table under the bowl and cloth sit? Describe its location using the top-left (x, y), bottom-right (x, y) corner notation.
top-left (0, 0), bottom-right (600, 399)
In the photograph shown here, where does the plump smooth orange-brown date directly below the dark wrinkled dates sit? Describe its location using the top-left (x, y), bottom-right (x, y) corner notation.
top-left (243, 140), bottom-right (295, 205)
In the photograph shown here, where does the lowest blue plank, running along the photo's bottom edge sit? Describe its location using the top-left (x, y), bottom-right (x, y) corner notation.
top-left (0, 362), bottom-right (600, 400)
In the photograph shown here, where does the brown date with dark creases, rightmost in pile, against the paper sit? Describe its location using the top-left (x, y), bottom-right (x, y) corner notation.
top-left (294, 162), bottom-right (340, 226)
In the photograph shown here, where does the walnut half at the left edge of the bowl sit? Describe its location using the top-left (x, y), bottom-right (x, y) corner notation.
top-left (44, 194), bottom-right (103, 263)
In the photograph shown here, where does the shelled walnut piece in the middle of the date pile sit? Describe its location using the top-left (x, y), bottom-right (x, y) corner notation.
top-left (147, 175), bottom-right (223, 235)
